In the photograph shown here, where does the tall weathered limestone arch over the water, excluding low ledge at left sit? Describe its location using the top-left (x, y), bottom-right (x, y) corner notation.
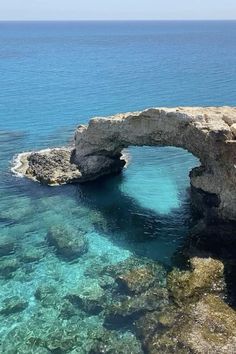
top-left (75, 107), bottom-right (236, 219)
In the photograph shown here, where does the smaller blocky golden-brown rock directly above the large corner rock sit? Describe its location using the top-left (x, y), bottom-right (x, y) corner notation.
top-left (167, 257), bottom-right (225, 304)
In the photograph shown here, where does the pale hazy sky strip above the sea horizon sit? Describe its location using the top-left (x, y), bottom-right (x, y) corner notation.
top-left (0, 0), bottom-right (236, 20)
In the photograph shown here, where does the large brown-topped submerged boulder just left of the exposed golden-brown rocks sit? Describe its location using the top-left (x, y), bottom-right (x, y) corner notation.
top-left (102, 257), bottom-right (168, 328)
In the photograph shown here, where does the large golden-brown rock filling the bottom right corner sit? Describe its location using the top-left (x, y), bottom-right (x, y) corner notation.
top-left (145, 294), bottom-right (236, 354)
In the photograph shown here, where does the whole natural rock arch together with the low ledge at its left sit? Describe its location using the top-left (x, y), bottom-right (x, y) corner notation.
top-left (12, 107), bottom-right (236, 220)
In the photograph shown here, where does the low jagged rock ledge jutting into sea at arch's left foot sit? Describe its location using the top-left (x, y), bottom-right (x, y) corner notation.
top-left (12, 147), bottom-right (128, 186)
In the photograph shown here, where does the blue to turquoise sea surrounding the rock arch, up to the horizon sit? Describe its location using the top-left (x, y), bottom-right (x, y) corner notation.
top-left (0, 21), bottom-right (236, 353)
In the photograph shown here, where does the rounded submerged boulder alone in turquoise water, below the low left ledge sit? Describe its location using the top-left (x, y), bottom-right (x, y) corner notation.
top-left (47, 225), bottom-right (88, 259)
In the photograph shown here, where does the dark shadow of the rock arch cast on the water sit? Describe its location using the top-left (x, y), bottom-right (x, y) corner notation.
top-left (77, 173), bottom-right (194, 263)
